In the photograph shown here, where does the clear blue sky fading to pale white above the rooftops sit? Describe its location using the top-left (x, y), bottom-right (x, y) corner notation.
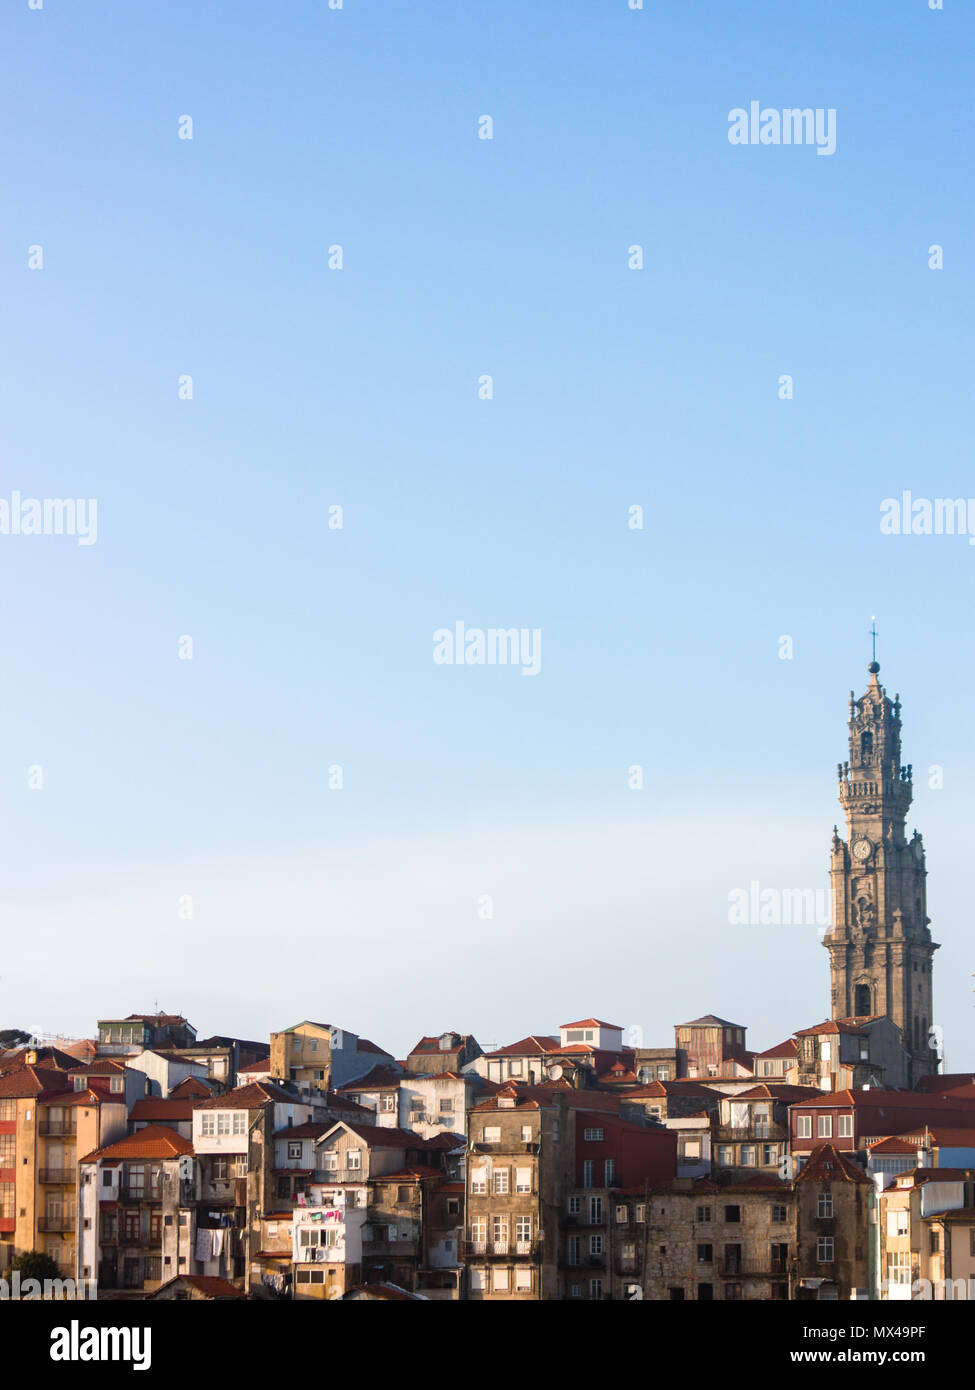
top-left (0, 0), bottom-right (975, 1068)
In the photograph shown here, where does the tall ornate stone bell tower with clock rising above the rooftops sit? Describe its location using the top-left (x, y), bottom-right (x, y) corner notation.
top-left (823, 662), bottom-right (937, 1086)
